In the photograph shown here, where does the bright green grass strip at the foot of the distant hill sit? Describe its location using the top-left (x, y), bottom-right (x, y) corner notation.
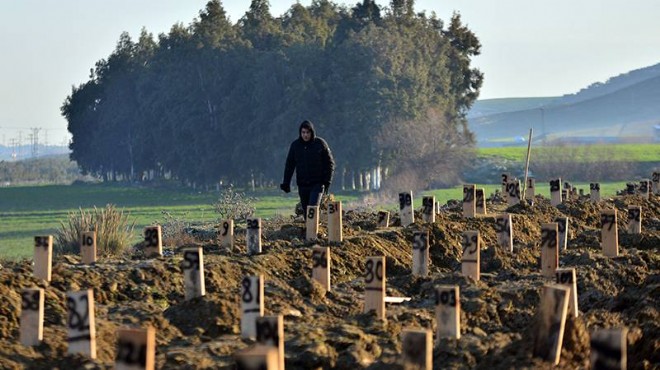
top-left (477, 144), bottom-right (660, 162)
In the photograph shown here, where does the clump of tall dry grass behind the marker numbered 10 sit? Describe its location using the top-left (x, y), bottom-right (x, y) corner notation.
top-left (55, 204), bottom-right (135, 256)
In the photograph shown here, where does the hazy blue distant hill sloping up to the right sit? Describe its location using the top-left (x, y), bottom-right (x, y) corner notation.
top-left (468, 64), bottom-right (660, 146)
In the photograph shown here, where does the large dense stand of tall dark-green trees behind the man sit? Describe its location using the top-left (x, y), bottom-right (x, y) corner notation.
top-left (61, 0), bottom-right (483, 191)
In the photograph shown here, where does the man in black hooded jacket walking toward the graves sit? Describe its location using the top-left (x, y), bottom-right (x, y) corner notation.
top-left (280, 120), bottom-right (335, 218)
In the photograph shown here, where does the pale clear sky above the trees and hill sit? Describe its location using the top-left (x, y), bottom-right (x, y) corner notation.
top-left (0, 0), bottom-right (660, 145)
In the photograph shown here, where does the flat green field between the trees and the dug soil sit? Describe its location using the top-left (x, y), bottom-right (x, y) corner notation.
top-left (0, 182), bottom-right (625, 259)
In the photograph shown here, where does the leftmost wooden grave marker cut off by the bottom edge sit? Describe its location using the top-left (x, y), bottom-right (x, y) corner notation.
top-left (115, 326), bottom-right (156, 370)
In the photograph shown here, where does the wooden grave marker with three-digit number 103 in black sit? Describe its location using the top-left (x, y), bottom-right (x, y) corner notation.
top-left (435, 285), bottom-right (461, 339)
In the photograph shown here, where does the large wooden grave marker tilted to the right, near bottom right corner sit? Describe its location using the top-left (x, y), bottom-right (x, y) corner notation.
top-left (534, 284), bottom-right (569, 365)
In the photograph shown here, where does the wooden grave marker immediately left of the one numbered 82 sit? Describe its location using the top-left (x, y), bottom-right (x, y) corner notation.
top-left (20, 288), bottom-right (44, 346)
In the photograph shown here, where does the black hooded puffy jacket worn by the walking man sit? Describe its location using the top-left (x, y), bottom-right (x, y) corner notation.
top-left (284, 121), bottom-right (335, 190)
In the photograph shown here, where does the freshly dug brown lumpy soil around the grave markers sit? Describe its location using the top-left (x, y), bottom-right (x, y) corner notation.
top-left (0, 196), bottom-right (660, 369)
